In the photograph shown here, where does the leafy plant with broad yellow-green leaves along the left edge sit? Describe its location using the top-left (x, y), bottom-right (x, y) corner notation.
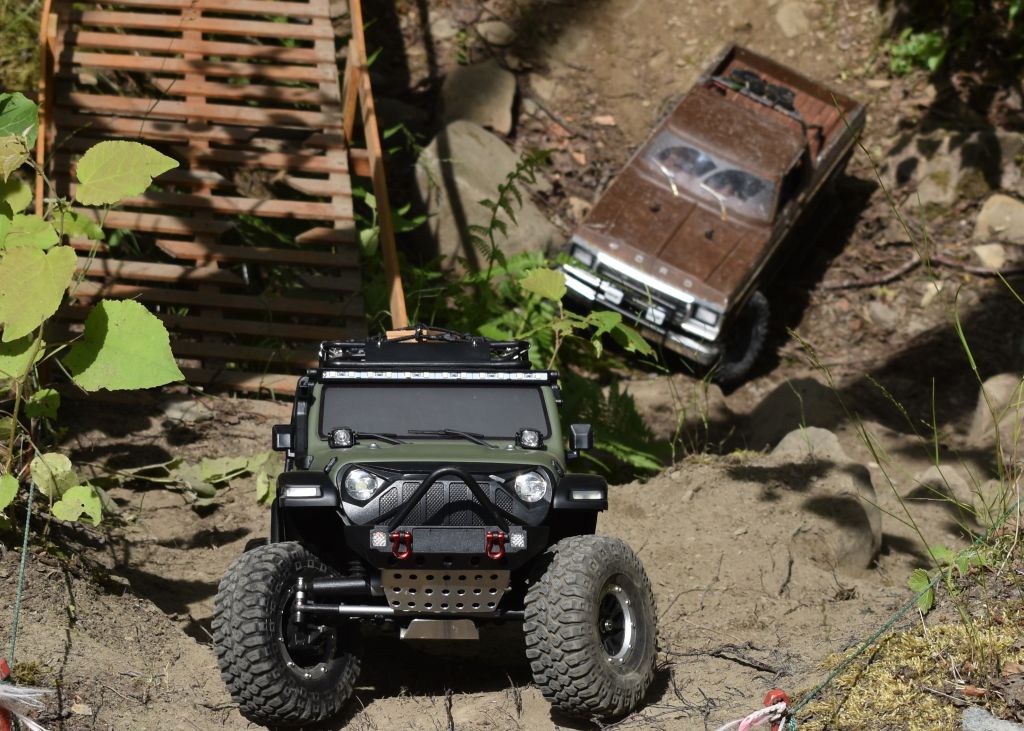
top-left (0, 93), bottom-right (183, 525)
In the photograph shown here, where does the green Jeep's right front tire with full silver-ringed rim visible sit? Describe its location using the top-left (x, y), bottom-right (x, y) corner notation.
top-left (523, 535), bottom-right (657, 720)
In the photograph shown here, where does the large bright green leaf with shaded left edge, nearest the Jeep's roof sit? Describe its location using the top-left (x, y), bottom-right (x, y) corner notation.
top-left (61, 298), bottom-right (184, 391)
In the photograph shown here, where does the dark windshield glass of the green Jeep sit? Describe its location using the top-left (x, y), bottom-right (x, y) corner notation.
top-left (319, 384), bottom-right (551, 439)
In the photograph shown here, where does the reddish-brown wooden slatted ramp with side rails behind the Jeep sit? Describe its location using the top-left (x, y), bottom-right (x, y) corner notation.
top-left (37, 0), bottom-right (404, 394)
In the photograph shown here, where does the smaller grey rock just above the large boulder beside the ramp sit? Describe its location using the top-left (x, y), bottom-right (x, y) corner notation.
top-left (441, 58), bottom-right (515, 134)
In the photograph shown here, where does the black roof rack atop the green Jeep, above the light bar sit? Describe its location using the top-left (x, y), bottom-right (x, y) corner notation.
top-left (319, 325), bottom-right (529, 370)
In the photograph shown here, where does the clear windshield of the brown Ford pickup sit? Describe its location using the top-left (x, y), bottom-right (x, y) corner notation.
top-left (643, 130), bottom-right (775, 221)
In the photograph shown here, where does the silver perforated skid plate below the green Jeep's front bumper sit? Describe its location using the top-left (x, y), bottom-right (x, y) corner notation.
top-left (381, 568), bottom-right (511, 614)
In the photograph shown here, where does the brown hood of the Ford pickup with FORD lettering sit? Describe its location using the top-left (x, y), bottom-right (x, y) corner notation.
top-left (575, 167), bottom-right (771, 309)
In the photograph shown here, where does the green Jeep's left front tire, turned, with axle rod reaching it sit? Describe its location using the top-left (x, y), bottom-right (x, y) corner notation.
top-left (212, 543), bottom-right (359, 727)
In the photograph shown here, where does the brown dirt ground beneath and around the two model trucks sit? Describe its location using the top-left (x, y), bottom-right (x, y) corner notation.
top-left (0, 0), bottom-right (1022, 731)
